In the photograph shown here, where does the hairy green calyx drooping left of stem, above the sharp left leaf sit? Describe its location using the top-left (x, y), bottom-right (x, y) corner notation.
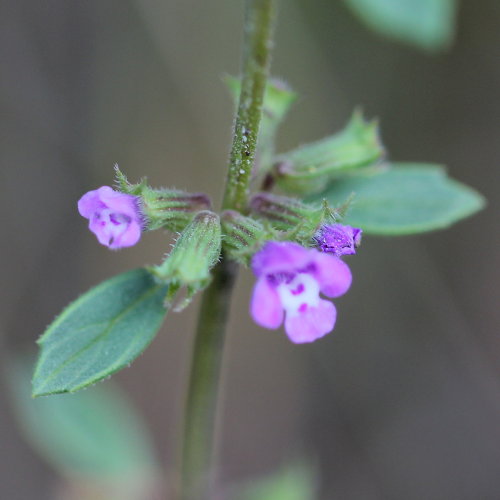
top-left (150, 210), bottom-right (221, 309)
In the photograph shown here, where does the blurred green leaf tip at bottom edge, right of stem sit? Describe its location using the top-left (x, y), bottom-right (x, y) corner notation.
top-left (237, 464), bottom-right (316, 500)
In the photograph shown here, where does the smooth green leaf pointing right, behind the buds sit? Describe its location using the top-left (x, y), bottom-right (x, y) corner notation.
top-left (316, 163), bottom-right (485, 235)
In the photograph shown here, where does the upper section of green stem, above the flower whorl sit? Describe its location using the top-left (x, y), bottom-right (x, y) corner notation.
top-left (222, 0), bottom-right (275, 212)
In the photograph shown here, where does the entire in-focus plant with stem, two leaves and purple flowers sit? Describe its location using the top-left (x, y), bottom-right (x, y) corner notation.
top-left (33, 0), bottom-right (483, 500)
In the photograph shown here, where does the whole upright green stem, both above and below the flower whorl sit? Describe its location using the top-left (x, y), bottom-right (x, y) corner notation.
top-left (179, 0), bottom-right (276, 500)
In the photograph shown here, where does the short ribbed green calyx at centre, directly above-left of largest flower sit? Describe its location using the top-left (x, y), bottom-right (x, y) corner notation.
top-left (221, 210), bottom-right (274, 265)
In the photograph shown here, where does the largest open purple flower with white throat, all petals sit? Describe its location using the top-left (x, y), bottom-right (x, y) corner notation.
top-left (250, 241), bottom-right (352, 344)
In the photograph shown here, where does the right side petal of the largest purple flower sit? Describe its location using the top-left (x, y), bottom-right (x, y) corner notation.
top-left (313, 252), bottom-right (352, 297)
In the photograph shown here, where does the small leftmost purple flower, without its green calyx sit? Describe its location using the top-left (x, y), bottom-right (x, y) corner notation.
top-left (78, 186), bottom-right (142, 250)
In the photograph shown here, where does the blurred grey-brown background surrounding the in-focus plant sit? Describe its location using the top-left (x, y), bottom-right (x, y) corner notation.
top-left (0, 0), bottom-right (500, 500)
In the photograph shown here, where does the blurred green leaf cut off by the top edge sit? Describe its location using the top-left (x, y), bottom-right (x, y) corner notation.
top-left (346, 0), bottom-right (457, 51)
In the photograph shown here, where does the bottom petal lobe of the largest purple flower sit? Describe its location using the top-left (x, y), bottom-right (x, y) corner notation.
top-left (285, 299), bottom-right (337, 344)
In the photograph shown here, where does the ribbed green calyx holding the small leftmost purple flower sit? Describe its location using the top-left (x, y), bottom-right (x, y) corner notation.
top-left (115, 165), bottom-right (211, 231)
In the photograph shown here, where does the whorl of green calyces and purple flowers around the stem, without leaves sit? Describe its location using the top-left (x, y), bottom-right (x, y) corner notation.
top-left (78, 79), bottom-right (368, 326)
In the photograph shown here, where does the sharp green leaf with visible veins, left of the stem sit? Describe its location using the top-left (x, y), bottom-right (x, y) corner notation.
top-left (33, 269), bottom-right (168, 396)
